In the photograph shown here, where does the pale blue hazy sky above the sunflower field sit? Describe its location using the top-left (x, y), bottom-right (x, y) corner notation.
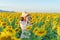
top-left (0, 0), bottom-right (60, 12)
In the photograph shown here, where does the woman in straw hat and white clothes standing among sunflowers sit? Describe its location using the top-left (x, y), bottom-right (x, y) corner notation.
top-left (20, 12), bottom-right (30, 38)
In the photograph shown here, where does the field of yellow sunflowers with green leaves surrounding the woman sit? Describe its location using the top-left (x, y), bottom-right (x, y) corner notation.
top-left (0, 12), bottom-right (60, 40)
